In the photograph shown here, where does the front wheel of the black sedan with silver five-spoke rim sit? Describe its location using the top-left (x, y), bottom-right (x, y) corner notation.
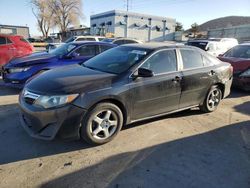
top-left (80, 102), bottom-right (123, 145)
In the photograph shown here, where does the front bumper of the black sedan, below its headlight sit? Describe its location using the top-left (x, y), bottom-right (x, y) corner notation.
top-left (19, 99), bottom-right (86, 140)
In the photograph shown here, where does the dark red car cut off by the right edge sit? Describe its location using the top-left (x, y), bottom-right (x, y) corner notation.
top-left (218, 43), bottom-right (250, 91)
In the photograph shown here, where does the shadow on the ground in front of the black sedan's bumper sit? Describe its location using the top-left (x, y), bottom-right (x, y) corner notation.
top-left (0, 104), bottom-right (89, 165)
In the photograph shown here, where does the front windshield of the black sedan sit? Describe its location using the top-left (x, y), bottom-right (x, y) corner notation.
top-left (82, 46), bottom-right (150, 74)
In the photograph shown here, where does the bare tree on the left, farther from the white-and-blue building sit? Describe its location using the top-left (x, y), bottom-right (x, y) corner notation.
top-left (30, 0), bottom-right (54, 38)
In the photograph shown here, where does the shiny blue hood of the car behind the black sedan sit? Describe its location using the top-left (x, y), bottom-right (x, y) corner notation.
top-left (8, 52), bottom-right (57, 67)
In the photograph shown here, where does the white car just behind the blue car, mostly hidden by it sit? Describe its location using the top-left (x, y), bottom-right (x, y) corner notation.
top-left (46, 36), bottom-right (105, 51)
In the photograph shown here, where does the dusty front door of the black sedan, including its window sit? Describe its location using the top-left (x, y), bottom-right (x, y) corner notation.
top-left (131, 49), bottom-right (181, 120)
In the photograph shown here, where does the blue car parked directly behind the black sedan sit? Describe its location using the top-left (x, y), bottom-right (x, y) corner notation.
top-left (2, 42), bottom-right (116, 88)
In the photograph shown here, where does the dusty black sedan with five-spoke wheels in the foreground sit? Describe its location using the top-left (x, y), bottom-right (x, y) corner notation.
top-left (19, 44), bottom-right (232, 145)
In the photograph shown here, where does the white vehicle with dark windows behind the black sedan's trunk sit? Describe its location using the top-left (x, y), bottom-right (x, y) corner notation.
top-left (187, 38), bottom-right (238, 57)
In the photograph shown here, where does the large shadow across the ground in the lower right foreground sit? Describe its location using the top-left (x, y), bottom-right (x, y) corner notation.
top-left (41, 121), bottom-right (250, 188)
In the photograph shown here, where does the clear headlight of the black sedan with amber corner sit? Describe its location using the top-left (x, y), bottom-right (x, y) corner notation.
top-left (35, 94), bottom-right (78, 108)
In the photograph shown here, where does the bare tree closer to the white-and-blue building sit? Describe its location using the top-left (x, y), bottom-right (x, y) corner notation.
top-left (50, 0), bottom-right (83, 37)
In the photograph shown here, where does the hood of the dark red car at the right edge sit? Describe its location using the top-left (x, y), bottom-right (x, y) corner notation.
top-left (219, 57), bottom-right (250, 73)
